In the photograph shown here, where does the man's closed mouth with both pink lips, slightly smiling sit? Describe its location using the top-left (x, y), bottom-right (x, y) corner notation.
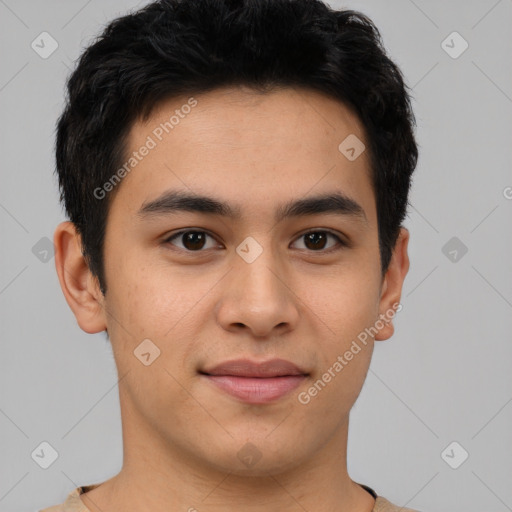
top-left (199, 359), bottom-right (309, 404)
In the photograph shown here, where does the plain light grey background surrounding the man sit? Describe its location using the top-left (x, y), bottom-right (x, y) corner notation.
top-left (0, 0), bottom-right (512, 512)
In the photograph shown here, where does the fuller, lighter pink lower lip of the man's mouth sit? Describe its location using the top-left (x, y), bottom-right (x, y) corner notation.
top-left (204, 375), bottom-right (306, 404)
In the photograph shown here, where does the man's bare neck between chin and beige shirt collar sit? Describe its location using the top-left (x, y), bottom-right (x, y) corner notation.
top-left (81, 400), bottom-right (375, 512)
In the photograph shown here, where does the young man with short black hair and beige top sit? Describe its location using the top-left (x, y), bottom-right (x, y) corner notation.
top-left (45, 0), bottom-right (418, 512)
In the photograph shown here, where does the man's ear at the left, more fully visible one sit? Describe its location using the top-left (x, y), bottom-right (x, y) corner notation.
top-left (53, 221), bottom-right (107, 334)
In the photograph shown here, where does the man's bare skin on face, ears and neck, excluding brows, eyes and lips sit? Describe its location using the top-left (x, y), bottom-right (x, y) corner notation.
top-left (54, 88), bottom-right (409, 512)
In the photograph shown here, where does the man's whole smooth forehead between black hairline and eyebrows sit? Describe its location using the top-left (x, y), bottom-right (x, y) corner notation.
top-left (116, 87), bottom-right (374, 224)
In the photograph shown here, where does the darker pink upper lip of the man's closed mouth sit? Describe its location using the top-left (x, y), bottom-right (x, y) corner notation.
top-left (201, 359), bottom-right (307, 378)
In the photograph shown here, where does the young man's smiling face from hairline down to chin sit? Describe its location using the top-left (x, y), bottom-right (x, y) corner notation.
top-left (56, 88), bottom-right (408, 474)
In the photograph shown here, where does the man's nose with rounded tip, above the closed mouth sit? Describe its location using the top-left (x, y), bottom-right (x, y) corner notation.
top-left (216, 245), bottom-right (300, 338)
